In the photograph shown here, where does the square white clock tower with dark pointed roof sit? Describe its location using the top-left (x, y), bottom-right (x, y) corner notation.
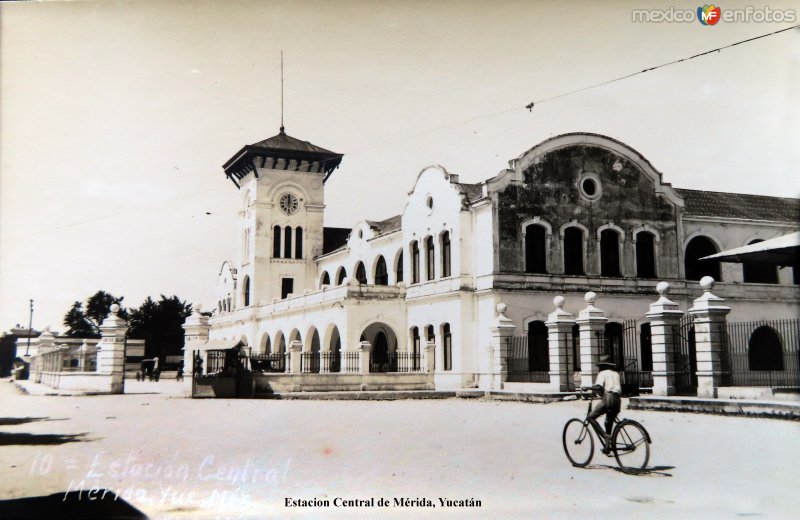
top-left (223, 127), bottom-right (342, 308)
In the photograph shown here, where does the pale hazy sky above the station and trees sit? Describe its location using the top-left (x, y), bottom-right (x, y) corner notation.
top-left (0, 0), bottom-right (800, 330)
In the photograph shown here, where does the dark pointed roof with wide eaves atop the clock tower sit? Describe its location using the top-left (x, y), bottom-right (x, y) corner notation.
top-left (222, 127), bottom-right (344, 187)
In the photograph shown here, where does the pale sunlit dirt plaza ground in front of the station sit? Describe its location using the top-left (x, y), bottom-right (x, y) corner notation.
top-left (0, 380), bottom-right (800, 519)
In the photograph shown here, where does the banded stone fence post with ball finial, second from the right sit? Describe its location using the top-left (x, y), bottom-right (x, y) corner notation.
top-left (646, 282), bottom-right (683, 395)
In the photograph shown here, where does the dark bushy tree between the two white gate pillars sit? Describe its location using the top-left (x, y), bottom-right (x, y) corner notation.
top-left (128, 294), bottom-right (192, 360)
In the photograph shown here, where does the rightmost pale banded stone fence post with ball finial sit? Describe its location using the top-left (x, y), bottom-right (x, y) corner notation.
top-left (689, 276), bottom-right (731, 397)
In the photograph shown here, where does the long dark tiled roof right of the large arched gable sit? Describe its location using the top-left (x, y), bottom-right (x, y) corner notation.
top-left (675, 189), bottom-right (800, 223)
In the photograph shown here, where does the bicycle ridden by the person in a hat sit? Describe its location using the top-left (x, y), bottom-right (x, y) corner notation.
top-left (562, 392), bottom-right (652, 475)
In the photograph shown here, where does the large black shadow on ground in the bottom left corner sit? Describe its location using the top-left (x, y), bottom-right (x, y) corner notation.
top-left (0, 489), bottom-right (147, 520)
